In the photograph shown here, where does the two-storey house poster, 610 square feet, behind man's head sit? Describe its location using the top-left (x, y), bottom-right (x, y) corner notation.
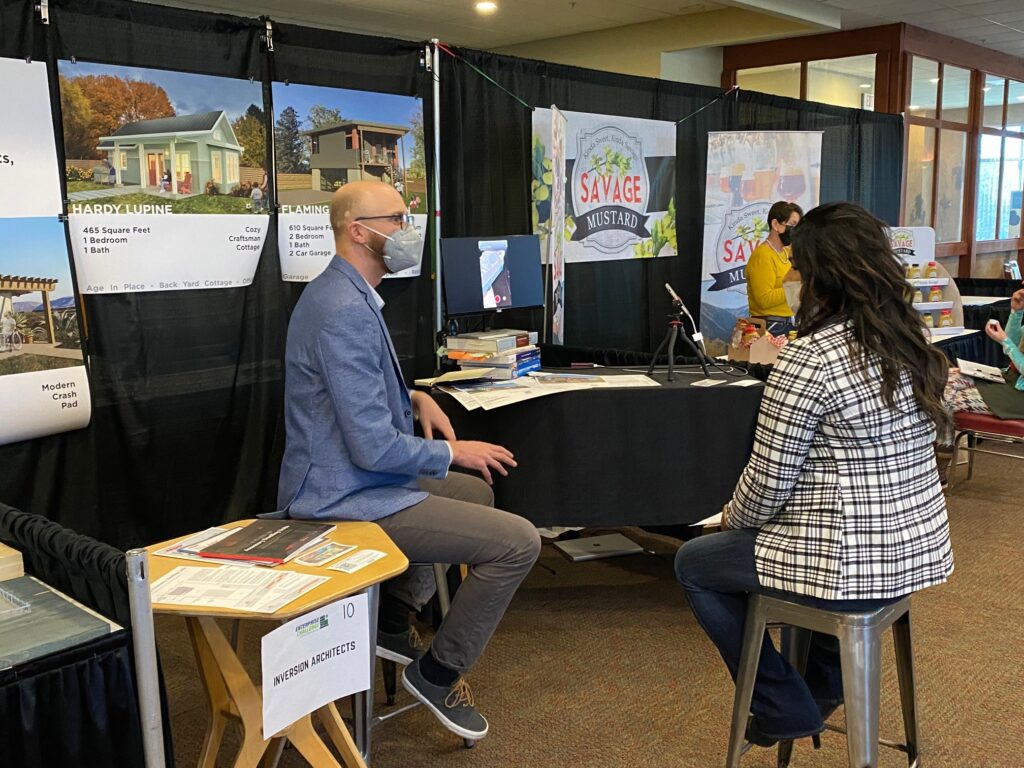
top-left (272, 82), bottom-right (427, 283)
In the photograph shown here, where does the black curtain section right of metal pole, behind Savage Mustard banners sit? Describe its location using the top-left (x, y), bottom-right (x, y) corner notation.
top-left (440, 49), bottom-right (903, 351)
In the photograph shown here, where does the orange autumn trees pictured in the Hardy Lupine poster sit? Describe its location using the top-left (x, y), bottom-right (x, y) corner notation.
top-left (60, 75), bottom-right (175, 159)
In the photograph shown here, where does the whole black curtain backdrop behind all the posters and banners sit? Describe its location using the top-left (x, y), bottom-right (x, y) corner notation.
top-left (0, 0), bottom-right (902, 549)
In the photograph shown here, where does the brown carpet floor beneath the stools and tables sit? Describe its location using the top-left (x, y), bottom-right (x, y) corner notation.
top-left (157, 457), bottom-right (1024, 768)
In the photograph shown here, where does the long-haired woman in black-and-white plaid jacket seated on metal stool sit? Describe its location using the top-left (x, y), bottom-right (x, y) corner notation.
top-left (676, 203), bottom-right (953, 746)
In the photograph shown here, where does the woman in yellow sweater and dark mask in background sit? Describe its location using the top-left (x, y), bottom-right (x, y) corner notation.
top-left (746, 200), bottom-right (804, 335)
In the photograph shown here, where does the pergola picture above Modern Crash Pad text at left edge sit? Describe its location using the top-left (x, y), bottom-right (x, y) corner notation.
top-left (0, 218), bottom-right (82, 376)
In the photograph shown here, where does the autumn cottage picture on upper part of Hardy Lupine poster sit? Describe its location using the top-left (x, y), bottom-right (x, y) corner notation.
top-left (58, 61), bottom-right (269, 214)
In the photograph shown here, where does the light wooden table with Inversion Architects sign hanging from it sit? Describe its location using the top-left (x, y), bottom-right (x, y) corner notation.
top-left (146, 520), bottom-right (409, 768)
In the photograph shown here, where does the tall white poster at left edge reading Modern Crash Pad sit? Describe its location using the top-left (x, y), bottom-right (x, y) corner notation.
top-left (0, 58), bottom-right (92, 444)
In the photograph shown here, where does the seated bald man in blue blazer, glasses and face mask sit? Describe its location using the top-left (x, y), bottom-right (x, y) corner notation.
top-left (278, 181), bottom-right (541, 739)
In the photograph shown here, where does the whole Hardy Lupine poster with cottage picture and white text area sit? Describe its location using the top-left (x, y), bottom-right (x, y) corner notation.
top-left (58, 60), bottom-right (268, 294)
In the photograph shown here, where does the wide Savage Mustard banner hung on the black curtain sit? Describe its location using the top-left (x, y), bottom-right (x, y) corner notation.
top-left (531, 110), bottom-right (678, 262)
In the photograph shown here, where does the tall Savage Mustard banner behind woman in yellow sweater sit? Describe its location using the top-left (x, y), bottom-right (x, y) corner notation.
top-left (700, 131), bottom-right (821, 356)
